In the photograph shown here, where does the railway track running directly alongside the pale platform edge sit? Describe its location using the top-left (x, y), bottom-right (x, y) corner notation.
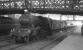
top-left (39, 28), bottom-right (73, 50)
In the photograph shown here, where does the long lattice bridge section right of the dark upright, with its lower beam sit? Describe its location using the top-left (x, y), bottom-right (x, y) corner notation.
top-left (25, 0), bottom-right (83, 15)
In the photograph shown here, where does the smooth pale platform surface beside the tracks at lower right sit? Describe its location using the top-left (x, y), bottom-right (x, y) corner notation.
top-left (51, 34), bottom-right (83, 50)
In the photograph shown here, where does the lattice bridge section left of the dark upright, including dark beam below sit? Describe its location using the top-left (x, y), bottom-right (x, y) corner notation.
top-left (0, 0), bottom-right (25, 15)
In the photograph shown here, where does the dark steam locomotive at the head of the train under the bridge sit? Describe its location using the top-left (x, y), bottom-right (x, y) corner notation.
top-left (11, 15), bottom-right (52, 42)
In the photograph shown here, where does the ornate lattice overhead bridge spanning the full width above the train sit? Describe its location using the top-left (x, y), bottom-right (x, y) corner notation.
top-left (0, 0), bottom-right (83, 15)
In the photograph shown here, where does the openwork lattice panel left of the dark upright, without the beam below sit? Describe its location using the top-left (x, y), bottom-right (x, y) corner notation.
top-left (0, 0), bottom-right (25, 9)
